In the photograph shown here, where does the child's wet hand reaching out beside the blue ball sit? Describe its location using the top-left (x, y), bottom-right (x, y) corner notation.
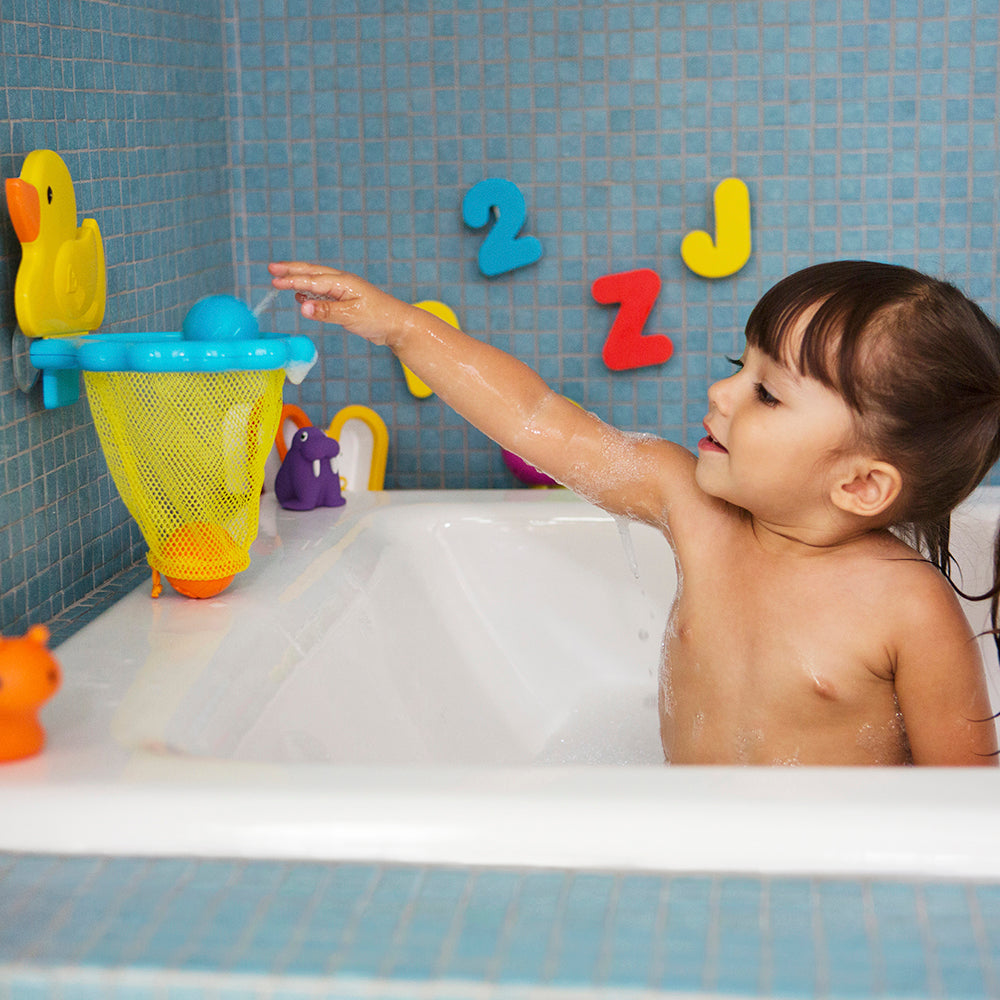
top-left (268, 261), bottom-right (412, 347)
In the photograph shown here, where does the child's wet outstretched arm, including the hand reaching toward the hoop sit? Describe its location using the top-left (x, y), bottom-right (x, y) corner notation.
top-left (269, 263), bottom-right (697, 523)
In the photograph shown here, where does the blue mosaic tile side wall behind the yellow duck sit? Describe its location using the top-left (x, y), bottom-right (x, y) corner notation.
top-left (0, 0), bottom-right (234, 634)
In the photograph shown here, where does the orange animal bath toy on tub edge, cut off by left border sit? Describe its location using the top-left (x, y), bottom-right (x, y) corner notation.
top-left (0, 625), bottom-right (62, 761)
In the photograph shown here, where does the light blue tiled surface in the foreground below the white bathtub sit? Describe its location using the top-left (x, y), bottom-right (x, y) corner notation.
top-left (0, 855), bottom-right (1000, 1000)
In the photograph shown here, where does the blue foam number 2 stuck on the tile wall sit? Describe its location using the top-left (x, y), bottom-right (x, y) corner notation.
top-left (462, 177), bottom-right (542, 278)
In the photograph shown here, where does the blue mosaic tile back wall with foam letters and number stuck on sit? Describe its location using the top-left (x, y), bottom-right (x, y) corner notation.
top-left (226, 0), bottom-right (1000, 487)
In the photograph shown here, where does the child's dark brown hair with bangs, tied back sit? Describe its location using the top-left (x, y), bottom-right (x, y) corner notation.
top-left (746, 261), bottom-right (1000, 649)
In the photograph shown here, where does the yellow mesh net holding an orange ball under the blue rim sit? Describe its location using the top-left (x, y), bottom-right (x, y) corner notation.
top-left (84, 368), bottom-right (285, 580)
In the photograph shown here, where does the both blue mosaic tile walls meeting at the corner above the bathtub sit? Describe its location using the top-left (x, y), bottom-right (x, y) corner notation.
top-left (0, 0), bottom-right (1000, 632)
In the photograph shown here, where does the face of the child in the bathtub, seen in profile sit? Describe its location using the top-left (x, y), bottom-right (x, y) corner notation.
top-left (695, 347), bottom-right (853, 527)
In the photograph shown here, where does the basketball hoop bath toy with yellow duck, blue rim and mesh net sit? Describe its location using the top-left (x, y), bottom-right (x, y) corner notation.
top-left (7, 150), bottom-right (316, 597)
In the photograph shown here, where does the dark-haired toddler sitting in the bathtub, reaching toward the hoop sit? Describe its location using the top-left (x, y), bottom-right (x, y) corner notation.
top-left (270, 261), bottom-right (1000, 765)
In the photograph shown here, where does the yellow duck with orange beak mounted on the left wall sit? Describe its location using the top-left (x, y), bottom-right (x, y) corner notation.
top-left (6, 149), bottom-right (106, 337)
